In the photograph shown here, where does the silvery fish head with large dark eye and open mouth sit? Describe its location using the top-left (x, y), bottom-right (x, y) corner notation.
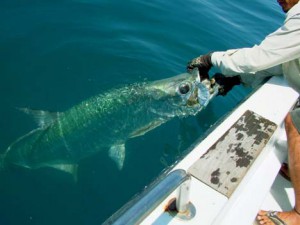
top-left (150, 68), bottom-right (217, 116)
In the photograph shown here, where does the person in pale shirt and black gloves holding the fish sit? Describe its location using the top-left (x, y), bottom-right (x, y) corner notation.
top-left (187, 0), bottom-right (300, 225)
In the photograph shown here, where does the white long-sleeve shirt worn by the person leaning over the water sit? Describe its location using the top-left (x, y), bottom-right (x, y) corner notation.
top-left (211, 2), bottom-right (300, 93)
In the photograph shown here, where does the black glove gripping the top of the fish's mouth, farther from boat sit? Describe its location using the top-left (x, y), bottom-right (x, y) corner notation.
top-left (187, 53), bottom-right (212, 80)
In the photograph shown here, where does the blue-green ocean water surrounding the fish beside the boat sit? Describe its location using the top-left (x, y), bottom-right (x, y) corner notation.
top-left (0, 0), bottom-right (284, 225)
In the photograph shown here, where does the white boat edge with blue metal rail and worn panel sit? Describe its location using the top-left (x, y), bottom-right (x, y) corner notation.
top-left (104, 76), bottom-right (298, 225)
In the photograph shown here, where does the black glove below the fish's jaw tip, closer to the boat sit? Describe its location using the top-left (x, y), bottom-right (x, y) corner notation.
top-left (213, 73), bottom-right (241, 96)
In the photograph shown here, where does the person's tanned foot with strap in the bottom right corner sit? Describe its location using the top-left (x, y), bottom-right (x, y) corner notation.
top-left (256, 210), bottom-right (300, 225)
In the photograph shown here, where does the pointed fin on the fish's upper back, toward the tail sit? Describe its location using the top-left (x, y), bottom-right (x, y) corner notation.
top-left (18, 108), bottom-right (60, 128)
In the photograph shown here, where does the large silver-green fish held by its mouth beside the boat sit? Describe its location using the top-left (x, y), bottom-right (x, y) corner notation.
top-left (0, 70), bottom-right (217, 177)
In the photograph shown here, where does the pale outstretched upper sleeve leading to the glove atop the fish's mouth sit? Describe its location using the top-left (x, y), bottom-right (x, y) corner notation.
top-left (212, 14), bottom-right (300, 76)
